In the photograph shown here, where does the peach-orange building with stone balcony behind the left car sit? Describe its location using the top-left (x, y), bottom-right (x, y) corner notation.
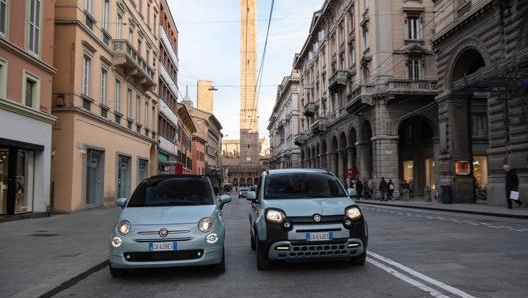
top-left (52, 0), bottom-right (160, 212)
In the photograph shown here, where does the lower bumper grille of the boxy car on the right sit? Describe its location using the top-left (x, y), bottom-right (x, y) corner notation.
top-left (282, 241), bottom-right (357, 258)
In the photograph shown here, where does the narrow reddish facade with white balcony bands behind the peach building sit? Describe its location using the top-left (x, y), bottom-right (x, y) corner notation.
top-left (158, 0), bottom-right (183, 173)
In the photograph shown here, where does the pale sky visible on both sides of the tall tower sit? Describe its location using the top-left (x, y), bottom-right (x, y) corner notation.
top-left (167, 0), bottom-right (324, 139)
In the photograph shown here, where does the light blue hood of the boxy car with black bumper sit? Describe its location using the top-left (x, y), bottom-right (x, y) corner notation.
top-left (265, 197), bottom-right (354, 216)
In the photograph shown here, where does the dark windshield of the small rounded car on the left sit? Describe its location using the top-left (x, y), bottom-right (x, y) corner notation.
top-left (128, 177), bottom-right (214, 207)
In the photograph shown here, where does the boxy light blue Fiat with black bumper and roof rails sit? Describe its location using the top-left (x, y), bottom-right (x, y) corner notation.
top-left (246, 169), bottom-right (368, 270)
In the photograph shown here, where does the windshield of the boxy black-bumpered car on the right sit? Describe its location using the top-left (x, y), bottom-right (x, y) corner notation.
top-left (264, 173), bottom-right (347, 199)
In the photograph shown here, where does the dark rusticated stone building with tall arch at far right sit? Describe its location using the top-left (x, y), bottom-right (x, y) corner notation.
top-left (432, 0), bottom-right (528, 205)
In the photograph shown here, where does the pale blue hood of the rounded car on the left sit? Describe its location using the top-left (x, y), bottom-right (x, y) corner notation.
top-left (120, 205), bottom-right (218, 225)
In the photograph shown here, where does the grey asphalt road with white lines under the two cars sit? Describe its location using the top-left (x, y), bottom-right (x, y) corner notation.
top-left (54, 198), bottom-right (528, 298)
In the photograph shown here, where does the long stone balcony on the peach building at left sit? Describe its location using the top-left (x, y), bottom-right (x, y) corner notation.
top-left (112, 39), bottom-right (156, 91)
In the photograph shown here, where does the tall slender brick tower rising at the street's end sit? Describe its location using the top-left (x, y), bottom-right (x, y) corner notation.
top-left (240, 0), bottom-right (259, 167)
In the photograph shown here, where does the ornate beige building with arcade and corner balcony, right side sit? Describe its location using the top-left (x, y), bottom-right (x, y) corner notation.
top-left (294, 0), bottom-right (438, 197)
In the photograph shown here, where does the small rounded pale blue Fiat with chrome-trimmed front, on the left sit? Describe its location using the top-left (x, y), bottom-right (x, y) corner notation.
top-left (109, 175), bottom-right (231, 277)
